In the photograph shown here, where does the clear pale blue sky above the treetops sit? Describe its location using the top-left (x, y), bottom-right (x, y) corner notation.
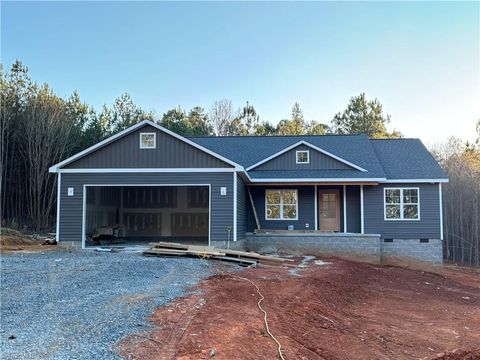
top-left (1, 2), bottom-right (480, 145)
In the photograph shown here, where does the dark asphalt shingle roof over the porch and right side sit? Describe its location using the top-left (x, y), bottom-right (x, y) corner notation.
top-left (189, 135), bottom-right (447, 179)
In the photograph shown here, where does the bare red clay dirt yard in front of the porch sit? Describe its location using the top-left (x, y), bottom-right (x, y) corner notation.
top-left (118, 259), bottom-right (480, 360)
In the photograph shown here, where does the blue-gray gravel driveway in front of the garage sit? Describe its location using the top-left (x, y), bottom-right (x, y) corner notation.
top-left (0, 251), bottom-right (220, 359)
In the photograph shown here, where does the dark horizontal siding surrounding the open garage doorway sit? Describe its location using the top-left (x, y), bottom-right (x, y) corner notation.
top-left (59, 172), bottom-right (233, 242)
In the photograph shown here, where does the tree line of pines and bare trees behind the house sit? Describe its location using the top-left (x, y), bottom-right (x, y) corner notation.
top-left (0, 61), bottom-right (480, 265)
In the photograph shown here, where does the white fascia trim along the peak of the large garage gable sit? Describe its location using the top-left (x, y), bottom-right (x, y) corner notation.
top-left (49, 120), bottom-right (244, 173)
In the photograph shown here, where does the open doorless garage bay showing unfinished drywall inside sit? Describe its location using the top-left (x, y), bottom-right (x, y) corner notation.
top-left (84, 185), bottom-right (210, 246)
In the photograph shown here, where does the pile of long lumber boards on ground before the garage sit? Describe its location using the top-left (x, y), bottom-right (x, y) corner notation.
top-left (143, 242), bottom-right (293, 266)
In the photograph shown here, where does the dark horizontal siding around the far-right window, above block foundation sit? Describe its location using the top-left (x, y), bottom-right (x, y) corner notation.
top-left (363, 183), bottom-right (440, 239)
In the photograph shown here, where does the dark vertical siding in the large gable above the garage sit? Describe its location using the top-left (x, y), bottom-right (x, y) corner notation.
top-left (64, 125), bottom-right (232, 169)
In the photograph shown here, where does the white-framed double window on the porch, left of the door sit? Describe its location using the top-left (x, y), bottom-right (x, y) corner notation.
top-left (265, 190), bottom-right (298, 220)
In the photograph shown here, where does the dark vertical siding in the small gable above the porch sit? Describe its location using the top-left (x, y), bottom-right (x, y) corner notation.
top-left (255, 145), bottom-right (353, 170)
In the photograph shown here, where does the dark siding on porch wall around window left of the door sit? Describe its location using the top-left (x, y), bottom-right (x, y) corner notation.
top-left (247, 185), bottom-right (315, 231)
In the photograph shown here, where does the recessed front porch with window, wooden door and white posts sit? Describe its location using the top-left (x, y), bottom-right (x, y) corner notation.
top-left (247, 183), bottom-right (366, 234)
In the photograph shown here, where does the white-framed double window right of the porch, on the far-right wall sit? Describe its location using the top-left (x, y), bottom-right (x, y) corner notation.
top-left (384, 188), bottom-right (420, 220)
